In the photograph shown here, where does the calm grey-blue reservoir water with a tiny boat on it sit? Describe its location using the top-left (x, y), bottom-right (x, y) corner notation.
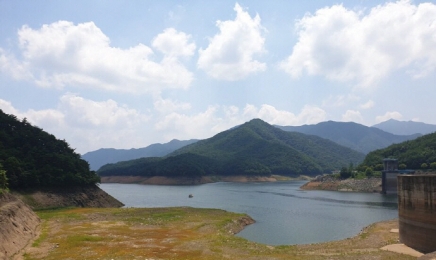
top-left (100, 181), bottom-right (398, 245)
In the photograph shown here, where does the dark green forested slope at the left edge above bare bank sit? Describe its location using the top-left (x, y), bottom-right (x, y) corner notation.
top-left (0, 110), bottom-right (100, 189)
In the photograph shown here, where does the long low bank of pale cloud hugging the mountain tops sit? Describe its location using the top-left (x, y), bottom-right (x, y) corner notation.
top-left (0, 93), bottom-right (326, 153)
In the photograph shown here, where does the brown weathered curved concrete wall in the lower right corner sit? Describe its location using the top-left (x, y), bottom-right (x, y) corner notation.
top-left (397, 175), bottom-right (436, 253)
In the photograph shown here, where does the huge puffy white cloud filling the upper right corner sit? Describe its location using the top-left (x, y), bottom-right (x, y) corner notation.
top-left (280, 0), bottom-right (436, 88)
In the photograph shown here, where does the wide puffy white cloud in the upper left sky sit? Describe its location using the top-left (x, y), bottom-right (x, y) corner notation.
top-left (0, 21), bottom-right (196, 93)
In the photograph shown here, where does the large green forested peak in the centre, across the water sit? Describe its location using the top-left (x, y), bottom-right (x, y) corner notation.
top-left (98, 119), bottom-right (364, 177)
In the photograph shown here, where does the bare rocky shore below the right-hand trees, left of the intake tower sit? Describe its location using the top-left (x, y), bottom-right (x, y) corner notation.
top-left (300, 175), bottom-right (382, 192)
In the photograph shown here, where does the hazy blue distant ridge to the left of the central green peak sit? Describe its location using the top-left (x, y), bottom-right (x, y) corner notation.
top-left (82, 139), bottom-right (198, 171)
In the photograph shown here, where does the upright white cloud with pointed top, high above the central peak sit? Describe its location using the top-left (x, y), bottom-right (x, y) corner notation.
top-left (198, 4), bottom-right (266, 81)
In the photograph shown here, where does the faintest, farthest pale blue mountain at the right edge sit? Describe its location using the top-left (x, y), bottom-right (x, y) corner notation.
top-left (372, 119), bottom-right (436, 135)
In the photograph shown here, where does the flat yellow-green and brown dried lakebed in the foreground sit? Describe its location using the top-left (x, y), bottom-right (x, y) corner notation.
top-left (20, 207), bottom-right (416, 260)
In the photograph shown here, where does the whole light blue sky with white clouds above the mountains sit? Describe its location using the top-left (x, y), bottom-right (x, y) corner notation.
top-left (0, 0), bottom-right (436, 154)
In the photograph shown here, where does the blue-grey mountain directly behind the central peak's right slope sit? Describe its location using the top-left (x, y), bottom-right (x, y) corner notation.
top-left (276, 121), bottom-right (420, 154)
